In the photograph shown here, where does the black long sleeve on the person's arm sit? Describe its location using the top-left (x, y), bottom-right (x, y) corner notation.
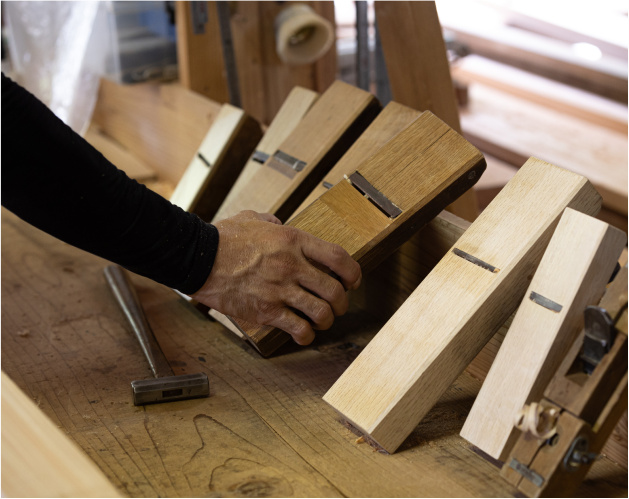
top-left (0, 73), bottom-right (218, 294)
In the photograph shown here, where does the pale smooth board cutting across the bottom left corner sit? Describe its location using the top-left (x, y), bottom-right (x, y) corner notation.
top-left (0, 371), bottom-right (122, 497)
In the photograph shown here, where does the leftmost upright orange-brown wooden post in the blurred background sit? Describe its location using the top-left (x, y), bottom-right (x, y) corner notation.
top-left (176, 0), bottom-right (229, 103)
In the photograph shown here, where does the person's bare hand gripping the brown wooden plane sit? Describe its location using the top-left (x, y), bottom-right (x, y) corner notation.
top-left (192, 211), bottom-right (362, 345)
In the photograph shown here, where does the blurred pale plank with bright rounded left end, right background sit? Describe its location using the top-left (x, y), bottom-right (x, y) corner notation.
top-left (452, 54), bottom-right (627, 134)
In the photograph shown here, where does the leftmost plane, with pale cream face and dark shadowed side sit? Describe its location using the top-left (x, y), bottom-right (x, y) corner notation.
top-left (170, 104), bottom-right (262, 222)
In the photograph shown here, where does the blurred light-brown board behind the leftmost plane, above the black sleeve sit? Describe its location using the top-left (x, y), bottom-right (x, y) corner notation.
top-left (92, 79), bottom-right (221, 184)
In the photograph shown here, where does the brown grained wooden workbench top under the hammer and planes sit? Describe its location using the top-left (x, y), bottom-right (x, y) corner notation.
top-left (0, 208), bottom-right (627, 497)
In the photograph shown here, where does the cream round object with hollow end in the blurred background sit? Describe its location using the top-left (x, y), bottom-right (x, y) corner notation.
top-left (275, 3), bottom-right (335, 66)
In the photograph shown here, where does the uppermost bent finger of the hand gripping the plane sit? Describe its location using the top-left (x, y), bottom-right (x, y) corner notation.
top-left (302, 233), bottom-right (362, 289)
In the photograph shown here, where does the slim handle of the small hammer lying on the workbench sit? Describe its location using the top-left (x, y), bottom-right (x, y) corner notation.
top-left (104, 265), bottom-right (174, 378)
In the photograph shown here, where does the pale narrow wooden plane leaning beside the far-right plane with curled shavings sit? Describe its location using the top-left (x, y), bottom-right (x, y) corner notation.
top-left (461, 209), bottom-right (627, 461)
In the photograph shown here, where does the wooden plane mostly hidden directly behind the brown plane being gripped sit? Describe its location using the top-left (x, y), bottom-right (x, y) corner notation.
top-left (293, 102), bottom-right (421, 216)
